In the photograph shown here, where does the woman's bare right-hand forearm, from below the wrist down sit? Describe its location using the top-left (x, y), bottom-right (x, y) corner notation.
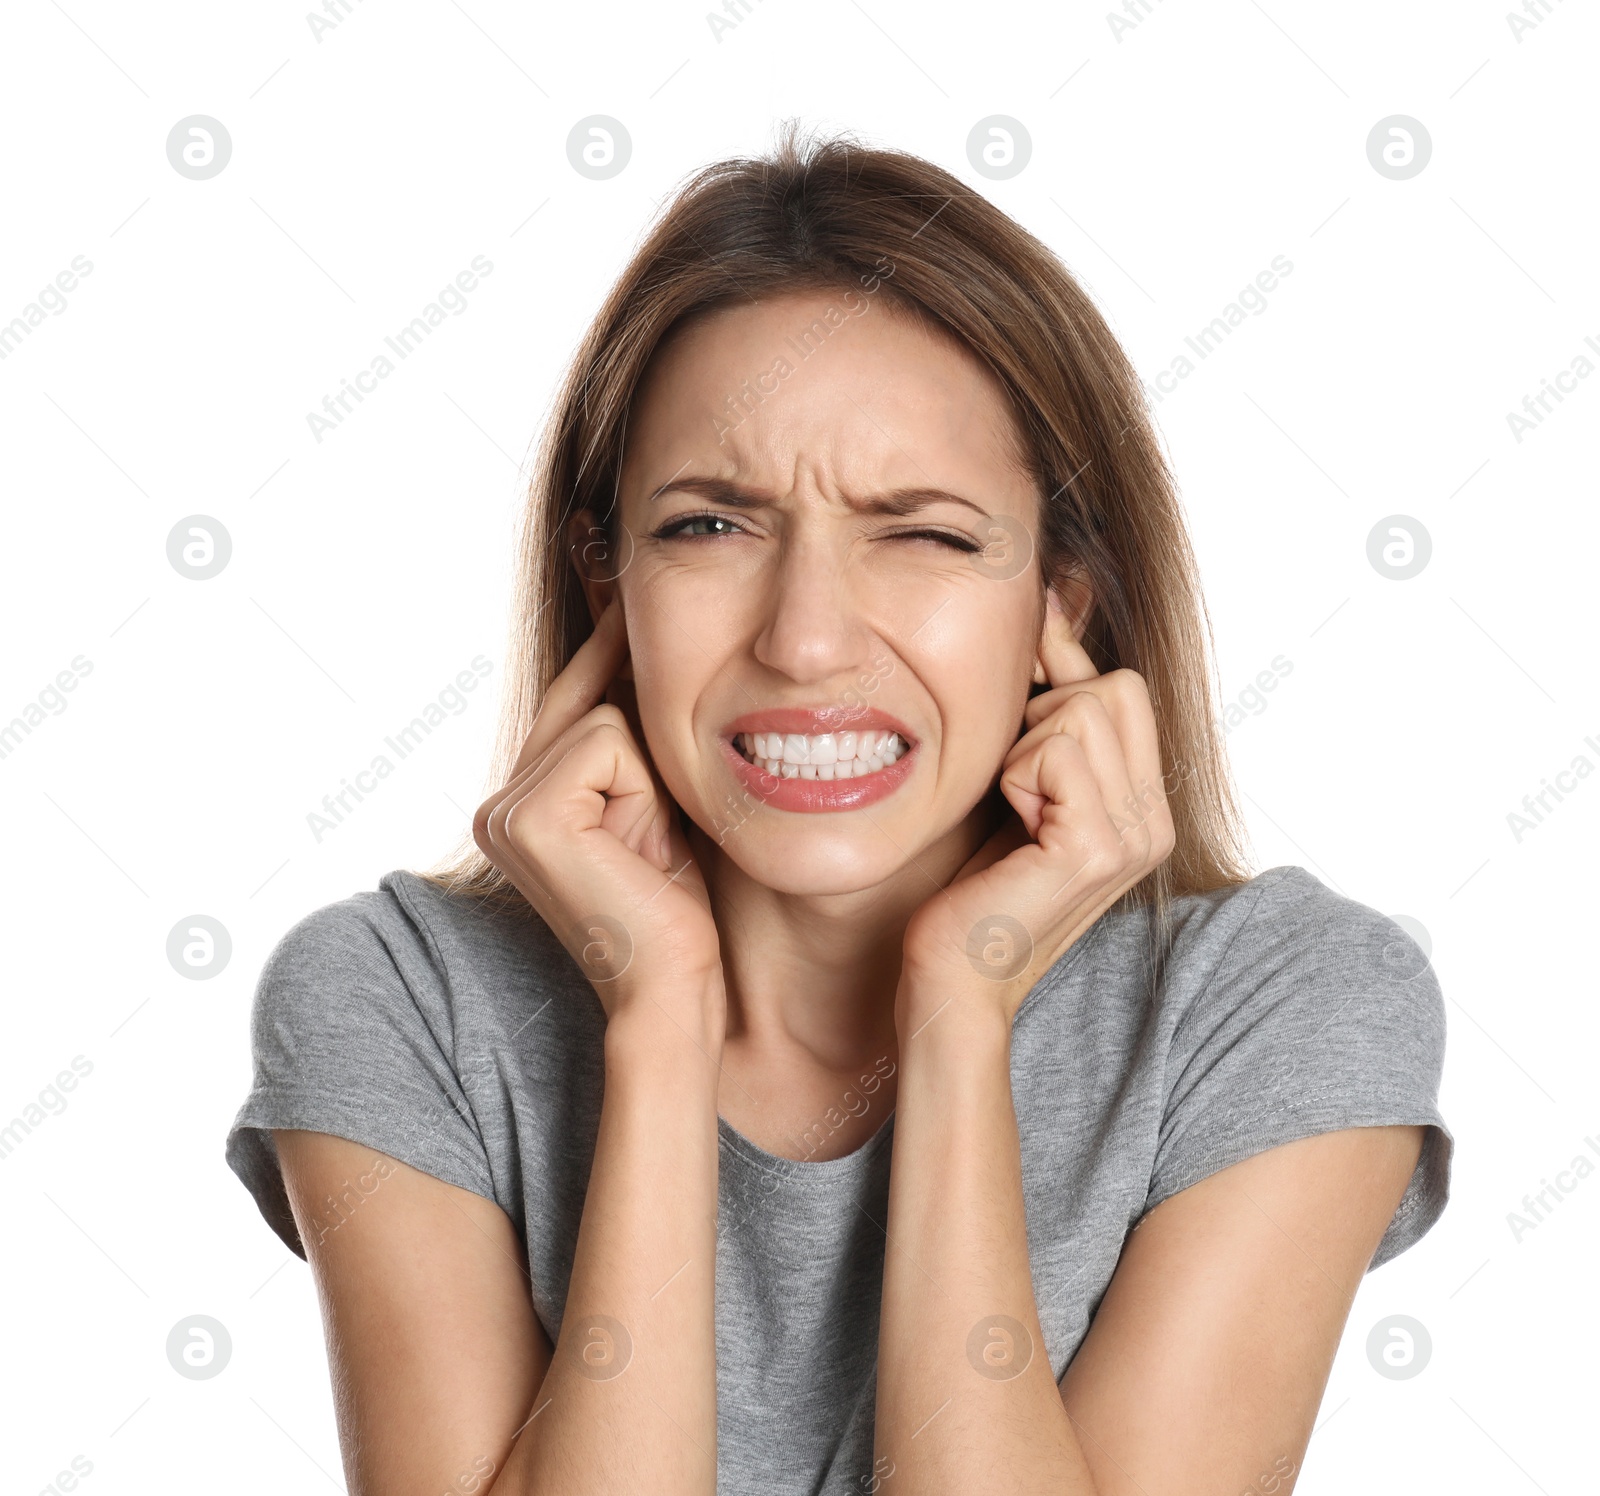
top-left (875, 992), bottom-right (1094, 1496)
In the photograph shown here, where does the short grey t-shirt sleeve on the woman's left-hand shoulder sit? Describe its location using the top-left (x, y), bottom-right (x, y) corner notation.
top-left (226, 890), bottom-right (494, 1258)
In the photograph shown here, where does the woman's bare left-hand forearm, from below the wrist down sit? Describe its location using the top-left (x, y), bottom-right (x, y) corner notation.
top-left (494, 994), bottom-right (722, 1496)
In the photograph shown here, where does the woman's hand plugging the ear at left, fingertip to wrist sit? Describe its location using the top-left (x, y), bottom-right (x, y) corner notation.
top-left (472, 598), bottom-right (722, 1027)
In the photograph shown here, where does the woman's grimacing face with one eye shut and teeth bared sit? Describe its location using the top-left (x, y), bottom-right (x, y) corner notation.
top-left (595, 290), bottom-right (1064, 894)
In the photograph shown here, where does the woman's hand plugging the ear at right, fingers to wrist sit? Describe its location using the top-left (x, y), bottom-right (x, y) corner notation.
top-left (898, 620), bottom-right (1174, 1035)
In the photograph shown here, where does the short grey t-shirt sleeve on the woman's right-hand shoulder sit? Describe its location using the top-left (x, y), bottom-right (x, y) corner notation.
top-left (1144, 867), bottom-right (1454, 1270)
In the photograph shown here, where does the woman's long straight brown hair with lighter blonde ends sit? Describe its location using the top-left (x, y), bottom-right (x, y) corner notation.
top-left (422, 122), bottom-right (1250, 925)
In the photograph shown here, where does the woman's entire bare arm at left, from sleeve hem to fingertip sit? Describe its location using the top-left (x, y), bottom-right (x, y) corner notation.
top-left (294, 605), bottom-right (725, 1496)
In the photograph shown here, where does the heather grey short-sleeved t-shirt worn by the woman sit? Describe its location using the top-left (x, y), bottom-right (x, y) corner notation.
top-left (227, 867), bottom-right (1453, 1496)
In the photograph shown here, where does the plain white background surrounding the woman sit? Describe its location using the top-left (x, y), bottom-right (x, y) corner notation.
top-left (0, 0), bottom-right (1600, 1496)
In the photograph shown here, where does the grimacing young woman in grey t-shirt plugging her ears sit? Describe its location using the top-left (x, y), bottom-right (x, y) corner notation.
top-left (229, 136), bottom-right (1451, 1496)
